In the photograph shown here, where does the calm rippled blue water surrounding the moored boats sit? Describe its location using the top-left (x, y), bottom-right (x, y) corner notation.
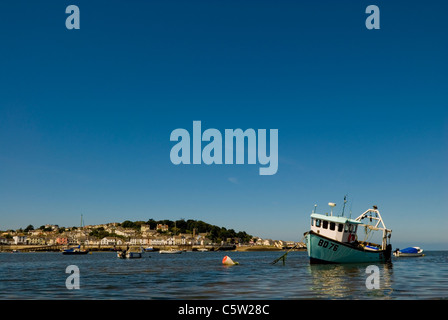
top-left (0, 251), bottom-right (448, 300)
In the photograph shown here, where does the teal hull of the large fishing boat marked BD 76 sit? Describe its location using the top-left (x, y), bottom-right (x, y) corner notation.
top-left (306, 231), bottom-right (391, 263)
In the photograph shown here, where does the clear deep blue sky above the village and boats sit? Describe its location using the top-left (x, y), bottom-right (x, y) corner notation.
top-left (0, 0), bottom-right (448, 249)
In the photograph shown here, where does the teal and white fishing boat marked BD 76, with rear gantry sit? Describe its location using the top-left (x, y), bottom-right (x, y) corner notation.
top-left (305, 199), bottom-right (392, 263)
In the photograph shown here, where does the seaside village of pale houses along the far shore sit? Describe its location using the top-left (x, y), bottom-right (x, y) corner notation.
top-left (0, 223), bottom-right (304, 250)
